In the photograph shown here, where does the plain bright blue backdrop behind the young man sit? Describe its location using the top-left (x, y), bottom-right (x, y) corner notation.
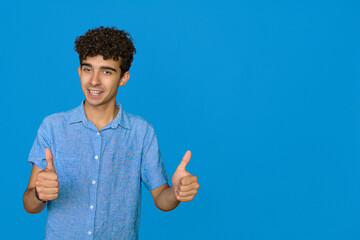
top-left (0, 0), bottom-right (360, 240)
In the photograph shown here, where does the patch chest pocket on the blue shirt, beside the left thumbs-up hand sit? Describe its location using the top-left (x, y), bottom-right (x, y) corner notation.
top-left (54, 152), bottom-right (81, 183)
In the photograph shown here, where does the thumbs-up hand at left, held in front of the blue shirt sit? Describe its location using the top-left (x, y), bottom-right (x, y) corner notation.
top-left (35, 148), bottom-right (59, 201)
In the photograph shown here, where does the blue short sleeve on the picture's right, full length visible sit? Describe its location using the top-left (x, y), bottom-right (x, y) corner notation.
top-left (141, 124), bottom-right (169, 190)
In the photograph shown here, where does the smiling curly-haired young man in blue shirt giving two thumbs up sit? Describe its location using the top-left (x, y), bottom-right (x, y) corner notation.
top-left (23, 27), bottom-right (199, 239)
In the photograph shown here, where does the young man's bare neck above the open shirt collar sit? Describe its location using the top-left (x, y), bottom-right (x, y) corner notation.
top-left (84, 100), bottom-right (119, 131)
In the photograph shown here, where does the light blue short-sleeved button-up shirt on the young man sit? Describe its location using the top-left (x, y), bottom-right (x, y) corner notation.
top-left (28, 102), bottom-right (169, 240)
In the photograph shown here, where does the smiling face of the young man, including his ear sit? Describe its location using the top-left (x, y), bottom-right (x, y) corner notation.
top-left (78, 55), bottom-right (130, 107)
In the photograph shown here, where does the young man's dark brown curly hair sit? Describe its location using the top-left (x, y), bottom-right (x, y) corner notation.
top-left (75, 26), bottom-right (136, 75)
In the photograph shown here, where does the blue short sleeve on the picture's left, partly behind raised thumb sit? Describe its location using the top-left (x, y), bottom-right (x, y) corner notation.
top-left (28, 118), bottom-right (51, 169)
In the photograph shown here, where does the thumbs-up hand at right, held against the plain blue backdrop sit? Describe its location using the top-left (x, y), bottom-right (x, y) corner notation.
top-left (172, 151), bottom-right (200, 201)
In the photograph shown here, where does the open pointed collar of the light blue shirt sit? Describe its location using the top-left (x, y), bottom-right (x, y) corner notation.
top-left (69, 100), bottom-right (130, 129)
